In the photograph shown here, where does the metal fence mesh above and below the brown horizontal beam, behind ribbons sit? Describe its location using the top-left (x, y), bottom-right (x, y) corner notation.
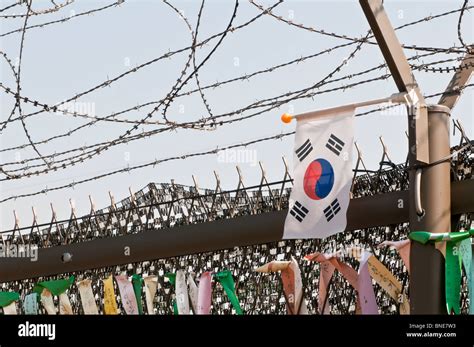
top-left (1, 147), bottom-right (474, 314)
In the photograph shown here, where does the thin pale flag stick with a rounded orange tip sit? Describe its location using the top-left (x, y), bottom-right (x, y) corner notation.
top-left (281, 92), bottom-right (410, 123)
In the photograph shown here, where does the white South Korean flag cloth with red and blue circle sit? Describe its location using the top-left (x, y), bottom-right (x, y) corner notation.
top-left (283, 108), bottom-right (355, 239)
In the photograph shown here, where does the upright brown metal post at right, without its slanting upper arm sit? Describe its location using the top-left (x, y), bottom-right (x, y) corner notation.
top-left (409, 105), bottom-right (451, 314)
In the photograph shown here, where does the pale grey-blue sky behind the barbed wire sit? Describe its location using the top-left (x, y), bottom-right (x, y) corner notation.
top-left (0, 0), bottom-right (474, 229)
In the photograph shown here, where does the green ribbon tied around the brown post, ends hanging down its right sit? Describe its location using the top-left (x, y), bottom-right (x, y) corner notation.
top-left (408, 229), bottom-right (474, 314)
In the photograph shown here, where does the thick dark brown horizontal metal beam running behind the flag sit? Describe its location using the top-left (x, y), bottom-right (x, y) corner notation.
top-left (0, 180), bottom-right (474, 283)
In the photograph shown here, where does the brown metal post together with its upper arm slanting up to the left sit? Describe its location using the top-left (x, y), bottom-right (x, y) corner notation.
top-left (359, 0), bottom-right (452, 314)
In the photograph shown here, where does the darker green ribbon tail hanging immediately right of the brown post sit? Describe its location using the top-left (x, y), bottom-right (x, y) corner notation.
top-left (445, 241), bottom-right (461, 314)
